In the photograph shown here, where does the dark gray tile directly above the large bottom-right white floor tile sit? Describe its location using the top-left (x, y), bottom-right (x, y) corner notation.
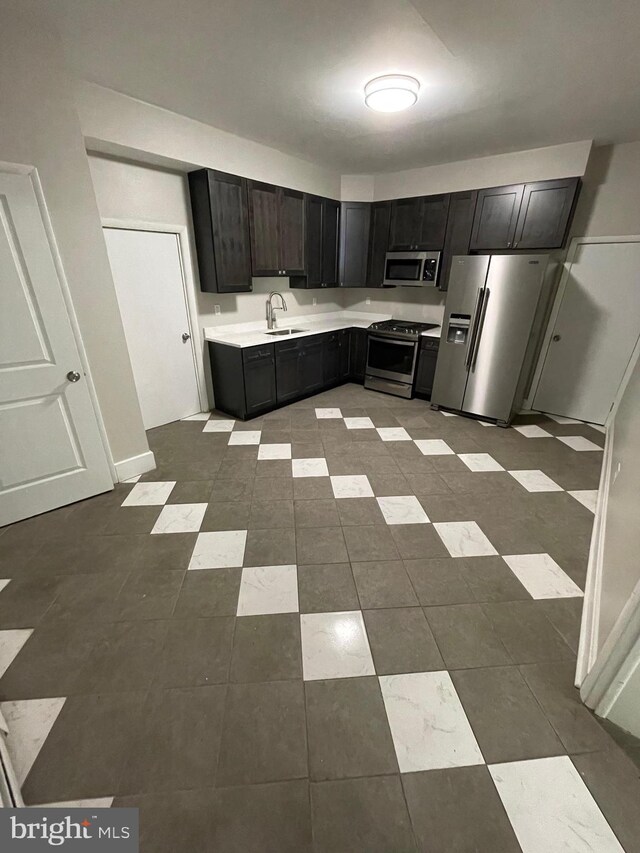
top-left (451, 666), bottom-right (565, 764)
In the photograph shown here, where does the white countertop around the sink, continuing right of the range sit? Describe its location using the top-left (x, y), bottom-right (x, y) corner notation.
top-left (203, 311), bottom-right (441, 347)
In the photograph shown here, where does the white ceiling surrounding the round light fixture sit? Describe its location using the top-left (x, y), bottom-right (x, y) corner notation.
top-left (36, 0), bottom-right (640, 173)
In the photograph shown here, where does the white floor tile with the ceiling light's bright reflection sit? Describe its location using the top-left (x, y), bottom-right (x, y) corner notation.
top-left (300, 610), bottom-right (375, 681)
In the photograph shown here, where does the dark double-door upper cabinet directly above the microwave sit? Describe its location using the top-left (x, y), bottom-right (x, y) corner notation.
top-left (389, 195), bottom-right (449, 252)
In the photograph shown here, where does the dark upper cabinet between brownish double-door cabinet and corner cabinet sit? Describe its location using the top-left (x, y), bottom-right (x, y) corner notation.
top-left (289, 195), bottom-right (340, 288)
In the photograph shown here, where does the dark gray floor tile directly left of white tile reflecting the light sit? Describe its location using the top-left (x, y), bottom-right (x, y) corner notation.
top-left (230, 613), bottom-right (302, 682)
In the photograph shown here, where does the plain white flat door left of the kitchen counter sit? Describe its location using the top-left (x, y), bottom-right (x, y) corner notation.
top-left (104, 228), bottom-right (202, 429)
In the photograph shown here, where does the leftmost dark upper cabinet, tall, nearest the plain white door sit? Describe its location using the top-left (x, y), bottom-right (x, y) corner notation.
top-left (189, 169), bottom-right (251, 293)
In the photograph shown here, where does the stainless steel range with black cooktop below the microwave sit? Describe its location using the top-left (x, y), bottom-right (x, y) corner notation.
top-left (364, 320), bottom-right (437, 398)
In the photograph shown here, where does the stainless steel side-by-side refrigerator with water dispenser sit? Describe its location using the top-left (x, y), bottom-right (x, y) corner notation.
top-left (431, 255), bottom-right (558, 425)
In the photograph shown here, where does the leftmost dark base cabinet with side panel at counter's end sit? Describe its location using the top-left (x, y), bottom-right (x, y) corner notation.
top-left (209, 341), bottom-right (277, 420)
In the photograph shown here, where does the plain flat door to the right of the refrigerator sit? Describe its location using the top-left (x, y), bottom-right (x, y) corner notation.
top-left (533, 242), bottom-right (640, 424)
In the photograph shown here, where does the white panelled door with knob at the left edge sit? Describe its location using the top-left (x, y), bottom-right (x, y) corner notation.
top-left (0, 171), bottom-right (113, 525)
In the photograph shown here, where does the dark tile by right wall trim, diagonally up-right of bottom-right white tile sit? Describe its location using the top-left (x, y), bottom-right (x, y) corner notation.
top-left (520, 661), bottom-right (611, 753)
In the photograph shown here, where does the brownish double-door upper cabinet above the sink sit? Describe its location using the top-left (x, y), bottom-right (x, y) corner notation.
top-left (247, 181), bottom-right (304, 276)
